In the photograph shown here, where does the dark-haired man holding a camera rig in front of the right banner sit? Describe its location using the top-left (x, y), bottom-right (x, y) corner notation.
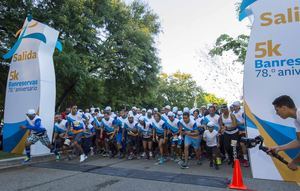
top-left (269, 95), bottom-right (300, 170)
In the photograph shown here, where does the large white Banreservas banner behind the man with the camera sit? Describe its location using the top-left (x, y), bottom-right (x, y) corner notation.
top-left (240, 0), bottom-right (300, 182)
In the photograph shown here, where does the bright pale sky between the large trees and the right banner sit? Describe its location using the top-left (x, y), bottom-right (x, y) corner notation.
top-left (125, 0), bottom-right (250, 102)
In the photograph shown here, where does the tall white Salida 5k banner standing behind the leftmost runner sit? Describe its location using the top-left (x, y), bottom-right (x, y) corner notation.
top-left (3, 18), bottom-right (59, 155)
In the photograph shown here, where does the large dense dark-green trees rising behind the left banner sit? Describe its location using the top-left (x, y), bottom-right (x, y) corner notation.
top-left (0, 0), bottom-right (160, 110)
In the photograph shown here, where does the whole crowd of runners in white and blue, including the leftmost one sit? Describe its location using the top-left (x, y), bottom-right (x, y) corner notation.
top-left (21, 101), bottom-right (249, 169)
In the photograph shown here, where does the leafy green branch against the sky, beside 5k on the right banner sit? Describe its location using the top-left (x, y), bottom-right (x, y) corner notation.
top-left (209, 34), bottom-right (249, 63)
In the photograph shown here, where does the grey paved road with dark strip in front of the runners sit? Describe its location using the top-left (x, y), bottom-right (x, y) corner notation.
top-left (0, 157), bottom-right (300, 191)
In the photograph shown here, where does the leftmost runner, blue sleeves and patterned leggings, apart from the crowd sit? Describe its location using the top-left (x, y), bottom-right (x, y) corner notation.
top-left (20, 109), bottom-right (58, 163)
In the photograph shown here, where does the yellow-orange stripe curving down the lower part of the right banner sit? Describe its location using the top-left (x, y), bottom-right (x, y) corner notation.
top-left (244, 102), bottom-right (300, 183)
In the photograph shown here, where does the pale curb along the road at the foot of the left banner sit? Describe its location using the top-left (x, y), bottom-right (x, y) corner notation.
top-left (0, 154), bottom-right (55, 170)
